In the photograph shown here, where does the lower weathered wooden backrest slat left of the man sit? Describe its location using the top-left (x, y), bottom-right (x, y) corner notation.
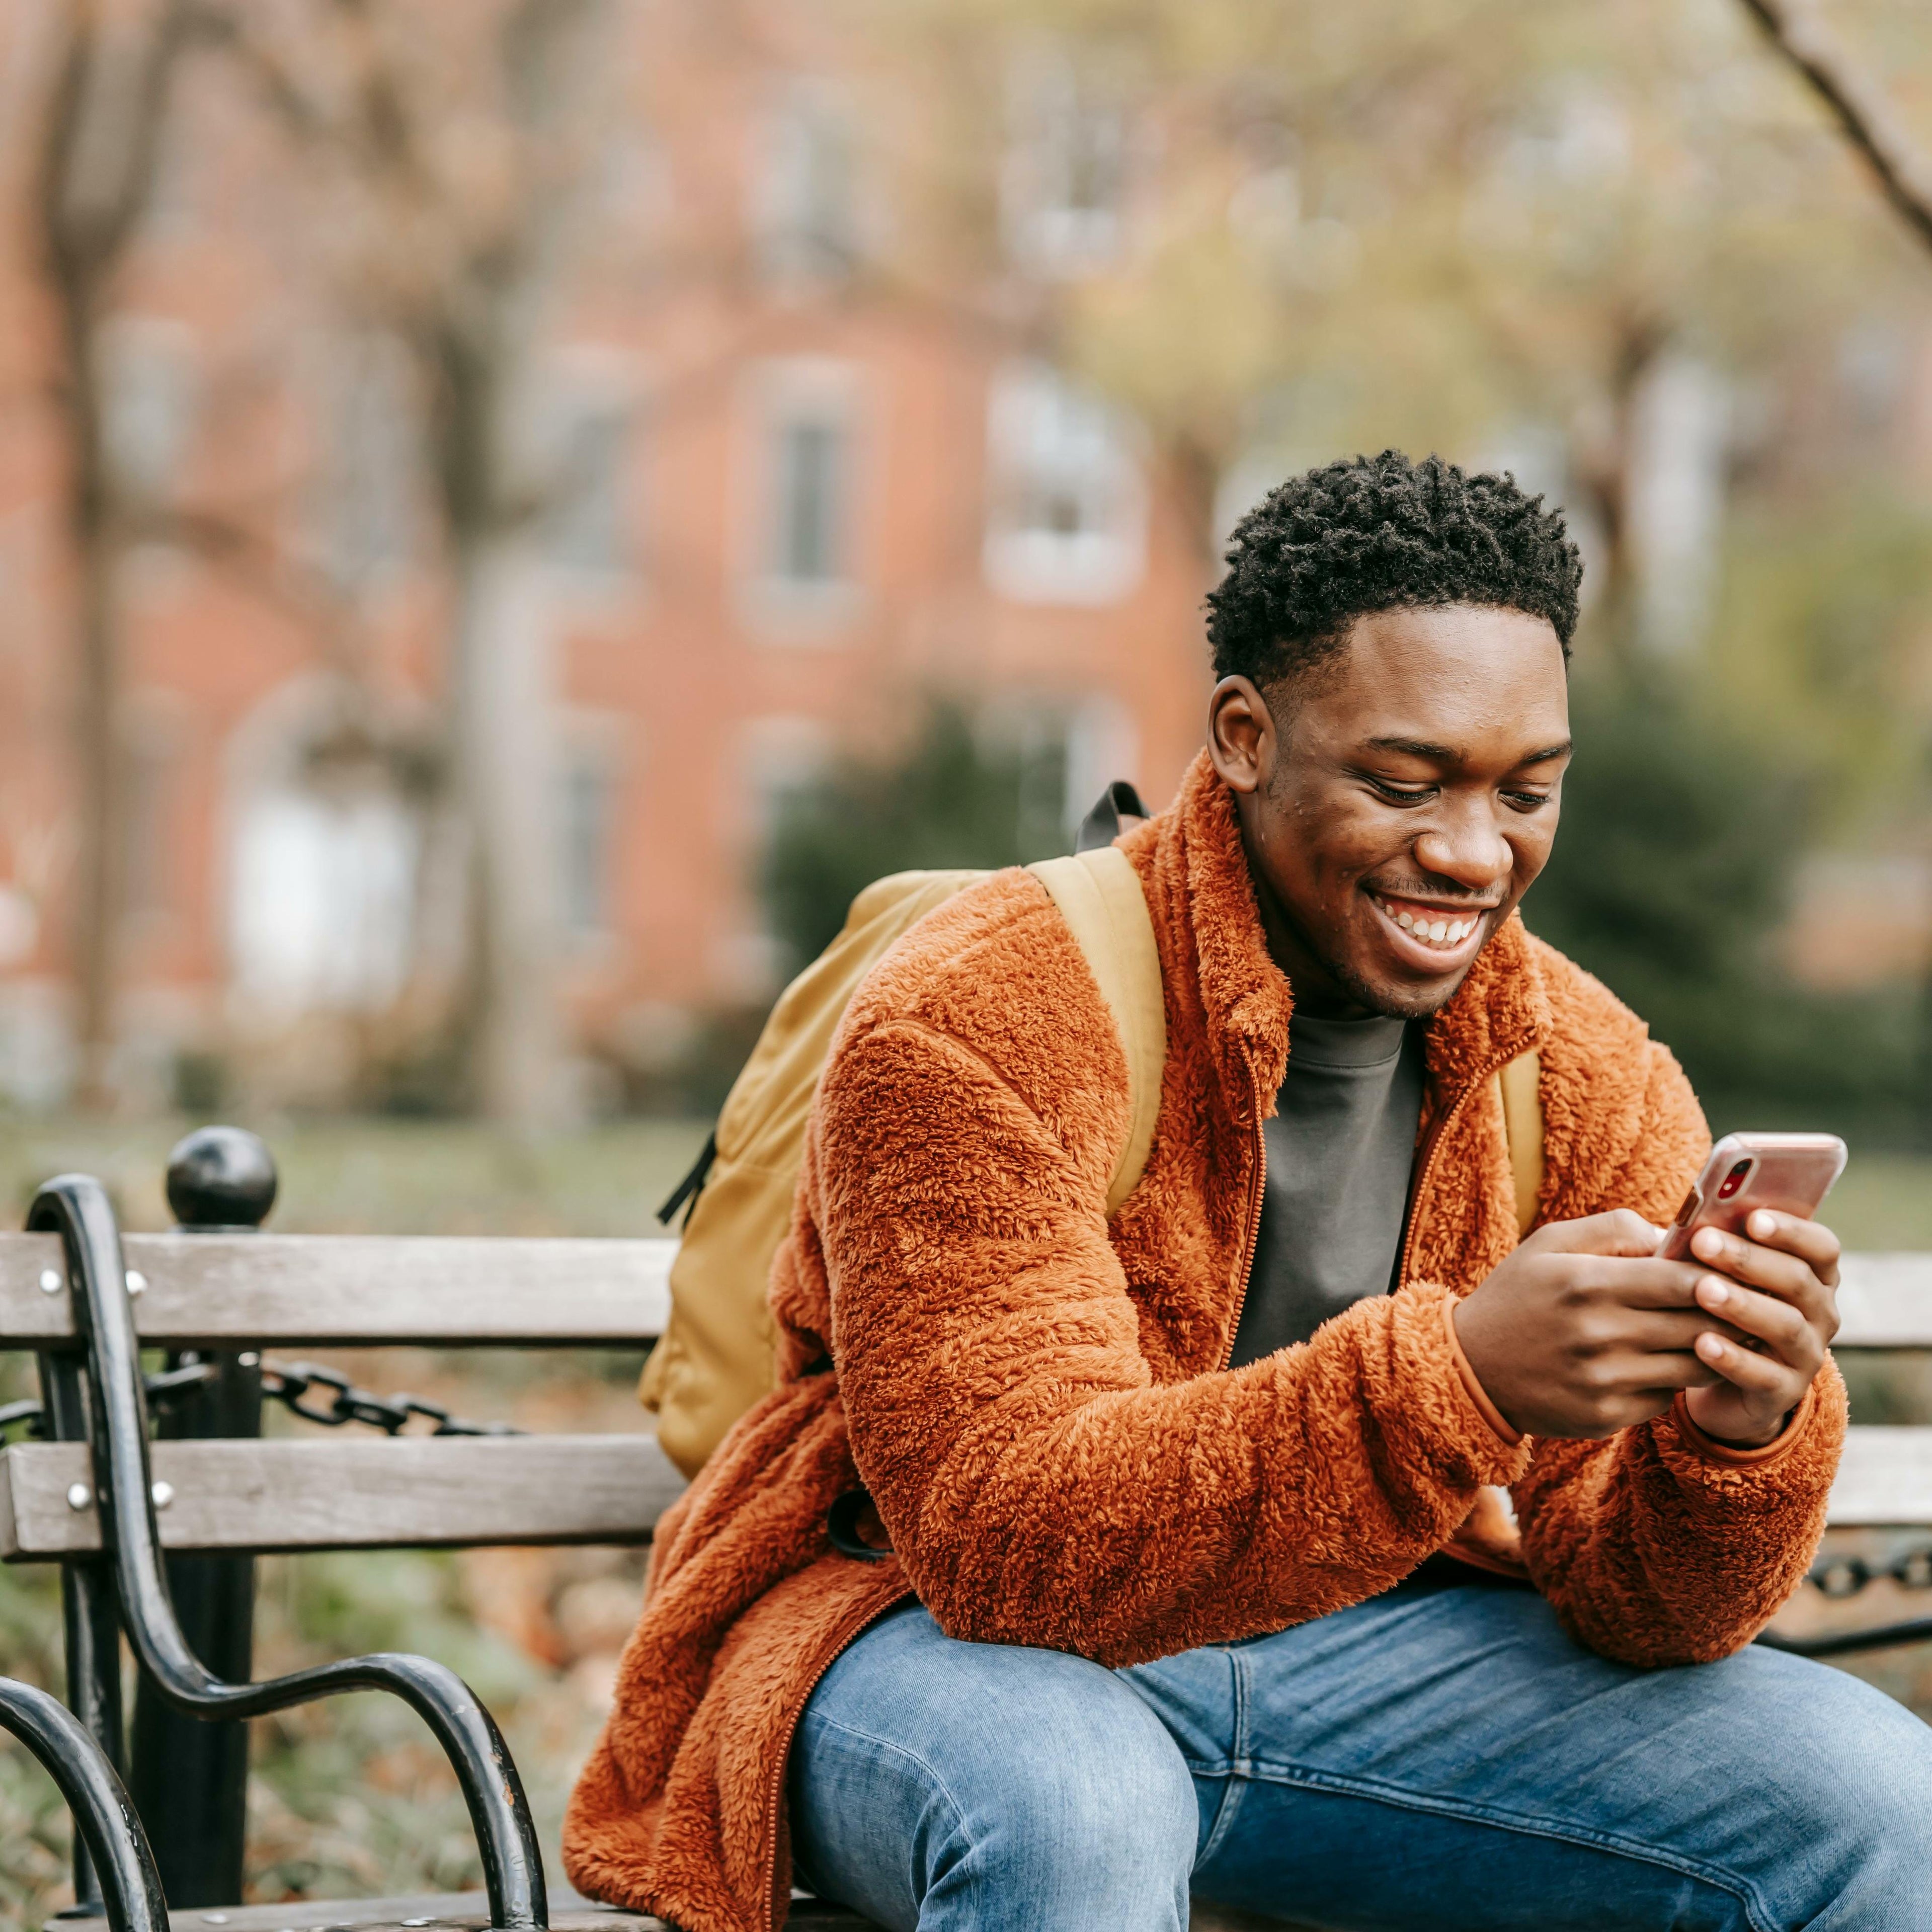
top-left (0, 1435), bottom-right (684, 1563)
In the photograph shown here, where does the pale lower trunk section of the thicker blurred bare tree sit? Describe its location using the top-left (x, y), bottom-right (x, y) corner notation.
top-left (450, 531), bottom-right (564, 1132)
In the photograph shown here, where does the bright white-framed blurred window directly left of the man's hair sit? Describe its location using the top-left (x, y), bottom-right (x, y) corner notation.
top-left (985, 363), bottom-right (1148, 605)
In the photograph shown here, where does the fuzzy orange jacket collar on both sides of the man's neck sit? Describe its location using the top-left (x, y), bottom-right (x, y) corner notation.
top-left (1148, 752), bottom-right (1550, 1107)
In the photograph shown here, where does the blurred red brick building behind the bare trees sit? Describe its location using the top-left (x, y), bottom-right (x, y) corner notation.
top-left (0, 6), bottom-right (1205, 1105)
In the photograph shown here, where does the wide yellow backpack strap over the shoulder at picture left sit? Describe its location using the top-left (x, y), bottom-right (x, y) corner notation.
top-left (1028, 846), bottom-right (1167, 1214)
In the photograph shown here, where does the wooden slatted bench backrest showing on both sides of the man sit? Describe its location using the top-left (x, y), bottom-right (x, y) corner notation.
top-left (0, 1233), bottom-right (1932, 1561)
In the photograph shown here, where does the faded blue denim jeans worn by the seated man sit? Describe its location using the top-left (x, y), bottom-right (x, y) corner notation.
top-left (790, 1582), bottom-right (1932, 1932)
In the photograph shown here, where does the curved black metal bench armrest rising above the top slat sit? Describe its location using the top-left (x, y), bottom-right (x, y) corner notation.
top-left (27, 1175), bottom-right (550, 1932)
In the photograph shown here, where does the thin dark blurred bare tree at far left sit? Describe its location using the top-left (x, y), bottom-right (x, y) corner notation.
top-left (33, 0), bottom-right (195, 1105)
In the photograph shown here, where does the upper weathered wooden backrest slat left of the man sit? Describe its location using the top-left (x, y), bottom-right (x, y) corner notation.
top-left (0, 1235), bottom-right (678, 1348)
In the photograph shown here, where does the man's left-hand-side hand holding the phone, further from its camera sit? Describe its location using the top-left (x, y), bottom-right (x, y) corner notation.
top-left (1455, 1208), bottom-right (1743, 1437)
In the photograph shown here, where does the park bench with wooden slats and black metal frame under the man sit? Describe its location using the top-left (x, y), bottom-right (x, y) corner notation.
top-left (11, 1130), bottom-right (1932, 1932)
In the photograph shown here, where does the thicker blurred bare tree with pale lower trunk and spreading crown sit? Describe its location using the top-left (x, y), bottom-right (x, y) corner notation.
top-left (222, 0), bottom-right (609, 1124)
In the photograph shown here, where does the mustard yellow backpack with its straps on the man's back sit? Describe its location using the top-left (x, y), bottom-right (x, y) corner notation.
top-left (637, 786), bottom-right (1544, 1476)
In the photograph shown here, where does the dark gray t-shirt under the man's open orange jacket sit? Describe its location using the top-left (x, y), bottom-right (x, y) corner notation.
top-left (1229, 1012), bottom-right (1424, 1368)
